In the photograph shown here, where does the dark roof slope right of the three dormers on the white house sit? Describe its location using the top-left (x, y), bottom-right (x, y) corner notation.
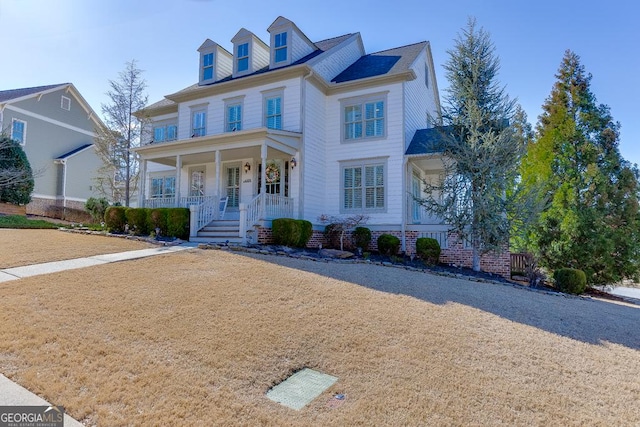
top-left (331, 42), bottom-right (427, 83)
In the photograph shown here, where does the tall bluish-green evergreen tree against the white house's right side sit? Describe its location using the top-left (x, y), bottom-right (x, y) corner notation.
top-left (419, 19), bottom-right (526, 271)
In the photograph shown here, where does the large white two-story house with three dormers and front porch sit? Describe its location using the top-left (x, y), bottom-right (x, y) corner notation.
top-left (136, 17), bottom-right (508, 278)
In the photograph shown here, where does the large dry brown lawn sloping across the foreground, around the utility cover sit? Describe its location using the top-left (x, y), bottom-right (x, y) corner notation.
top-left (0, 233), bottom-right (640, 426)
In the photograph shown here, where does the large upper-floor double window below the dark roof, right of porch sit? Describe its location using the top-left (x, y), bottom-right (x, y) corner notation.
top-left (343, 100), bottom-right (385, 140)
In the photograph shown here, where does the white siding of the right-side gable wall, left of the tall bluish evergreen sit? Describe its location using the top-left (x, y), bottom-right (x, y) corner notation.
top-left (404, 50), bottom-right (439, 150)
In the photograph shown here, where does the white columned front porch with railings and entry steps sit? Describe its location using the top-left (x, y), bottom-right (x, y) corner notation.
top-left (136, 129), bottom-right (301, 244)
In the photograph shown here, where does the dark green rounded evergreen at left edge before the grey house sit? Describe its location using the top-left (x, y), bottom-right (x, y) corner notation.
top-left (0, 135), bottom-right (34, 205)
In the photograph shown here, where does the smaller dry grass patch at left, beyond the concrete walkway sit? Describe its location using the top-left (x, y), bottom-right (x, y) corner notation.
top-left (0, 228), bottom-right (152, 269)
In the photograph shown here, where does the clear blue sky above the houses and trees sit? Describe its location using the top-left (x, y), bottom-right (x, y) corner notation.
top-left (0, 0), bottom-right (640, 164)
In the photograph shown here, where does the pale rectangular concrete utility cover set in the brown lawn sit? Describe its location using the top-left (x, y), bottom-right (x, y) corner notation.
top-left (267, 368), bottom-right (338, 411)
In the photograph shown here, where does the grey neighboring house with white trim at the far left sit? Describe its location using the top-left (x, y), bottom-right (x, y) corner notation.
top-left (0, 83), bottom-right (102, 216)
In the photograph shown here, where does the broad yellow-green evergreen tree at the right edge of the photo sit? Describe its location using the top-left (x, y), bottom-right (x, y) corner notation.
top-left (521, 51), bottom-right (640, 285)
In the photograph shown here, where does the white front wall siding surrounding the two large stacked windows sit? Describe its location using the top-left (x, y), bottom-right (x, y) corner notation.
top-left (320, 83), bottom-right (404, 225)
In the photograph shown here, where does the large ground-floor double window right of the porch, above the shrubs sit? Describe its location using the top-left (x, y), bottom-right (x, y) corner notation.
top-left (340, 161), bottom-right (386, 213)
